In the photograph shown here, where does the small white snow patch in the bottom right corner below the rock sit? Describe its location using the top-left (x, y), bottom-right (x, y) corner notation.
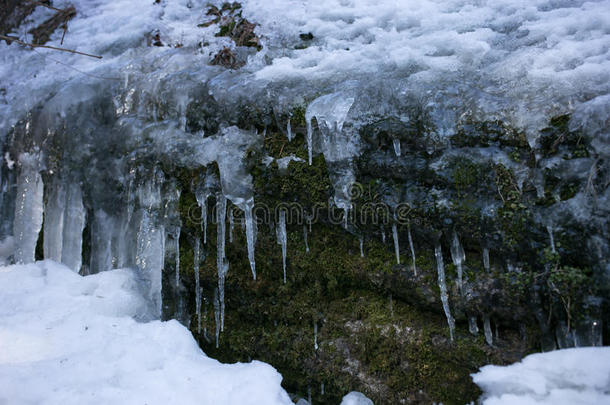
top-left (472, 347), bottom-right (610, 405)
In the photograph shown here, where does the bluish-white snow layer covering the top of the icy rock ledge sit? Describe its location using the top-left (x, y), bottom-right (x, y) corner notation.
top-left (0, 0), bottom-right (610, 145)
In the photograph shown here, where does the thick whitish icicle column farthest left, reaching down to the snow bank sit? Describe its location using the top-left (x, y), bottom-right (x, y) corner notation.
top-left (13, 153), bottom-right (44, 263)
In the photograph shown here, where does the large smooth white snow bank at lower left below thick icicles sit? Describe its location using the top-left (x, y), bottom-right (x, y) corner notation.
top-left (0, 261), bottom-right (292, 405)
